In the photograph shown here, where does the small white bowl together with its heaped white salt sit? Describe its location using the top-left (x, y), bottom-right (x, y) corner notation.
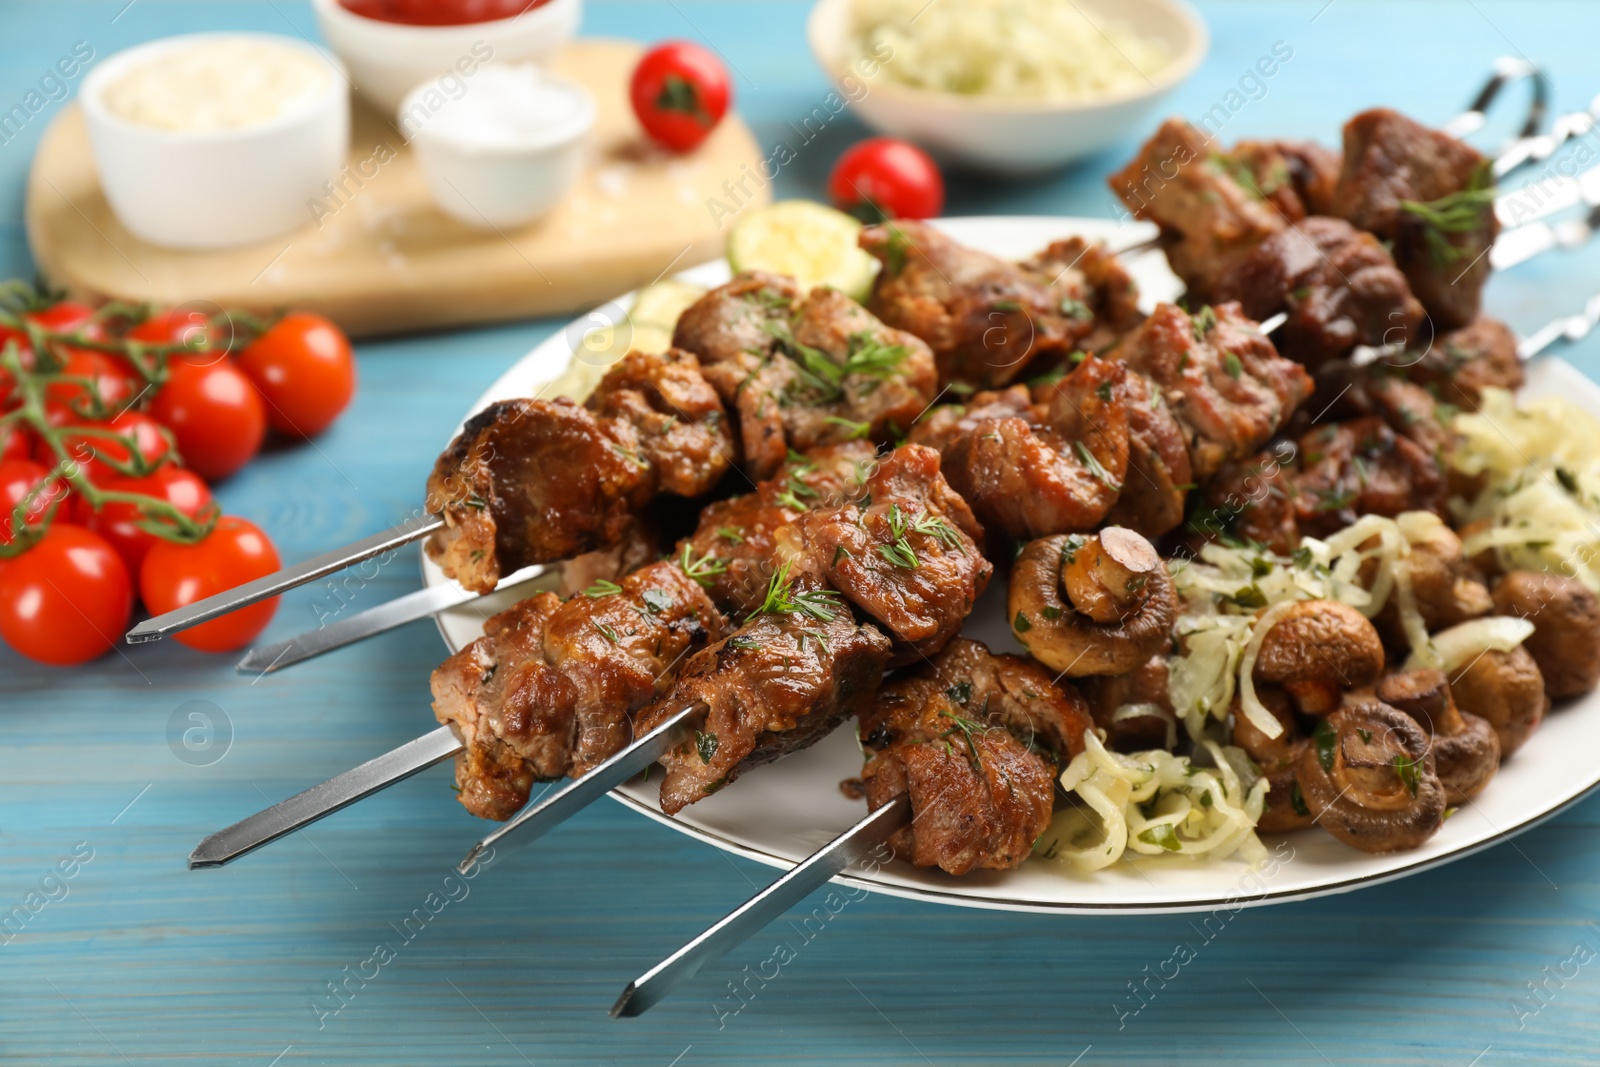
top-left (398, 64), bottom-right (595, 229)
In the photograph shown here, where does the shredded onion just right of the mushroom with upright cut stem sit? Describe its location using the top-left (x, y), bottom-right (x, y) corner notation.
top-left (1166, 512), bottom-right (1442, 741)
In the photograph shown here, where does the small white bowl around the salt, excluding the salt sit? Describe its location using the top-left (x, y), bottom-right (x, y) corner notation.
top-left (400, 66), bottom-right (595, 229)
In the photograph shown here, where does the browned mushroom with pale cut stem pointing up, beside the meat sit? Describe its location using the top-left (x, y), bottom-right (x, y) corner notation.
top-left (1006, 526), bottom-right (1178, 678)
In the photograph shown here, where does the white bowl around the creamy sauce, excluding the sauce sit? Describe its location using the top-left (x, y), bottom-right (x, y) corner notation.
top-left (78, 34), bottom-right (350, 248)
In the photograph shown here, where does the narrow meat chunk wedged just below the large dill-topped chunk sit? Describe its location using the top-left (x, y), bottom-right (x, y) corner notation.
top-left (675, 442), bottom-right (877, 616)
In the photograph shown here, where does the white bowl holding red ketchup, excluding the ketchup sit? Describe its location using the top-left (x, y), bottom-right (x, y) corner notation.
top-left (312, 0), bottom-right (584, 117)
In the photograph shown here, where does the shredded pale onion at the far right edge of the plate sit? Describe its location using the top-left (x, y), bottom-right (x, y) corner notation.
top-left (1451, 389), bottom-right (1600, 592)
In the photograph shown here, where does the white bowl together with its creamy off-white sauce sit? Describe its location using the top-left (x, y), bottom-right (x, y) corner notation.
top-left (80, 34), bottom-right (350, 248)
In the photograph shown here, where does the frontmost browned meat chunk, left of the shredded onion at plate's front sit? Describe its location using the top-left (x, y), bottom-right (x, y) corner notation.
top-left (861, 638), bottom-right (1091, 875)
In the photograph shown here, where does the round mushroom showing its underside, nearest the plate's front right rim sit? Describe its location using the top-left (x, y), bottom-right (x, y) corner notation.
top-left (1294, 701), bottom-right (1445, 853)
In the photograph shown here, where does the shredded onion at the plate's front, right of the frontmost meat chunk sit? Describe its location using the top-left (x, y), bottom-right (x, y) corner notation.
top-left (1034, 731), bottom-right (1269, 870)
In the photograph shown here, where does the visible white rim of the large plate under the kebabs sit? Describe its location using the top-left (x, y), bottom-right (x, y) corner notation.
top-left (419, 214), bottom-right (1600, 915)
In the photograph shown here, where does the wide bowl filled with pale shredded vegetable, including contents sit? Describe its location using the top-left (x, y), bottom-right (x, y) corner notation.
top-left (806, 0), bottom-right (1210, 174)
